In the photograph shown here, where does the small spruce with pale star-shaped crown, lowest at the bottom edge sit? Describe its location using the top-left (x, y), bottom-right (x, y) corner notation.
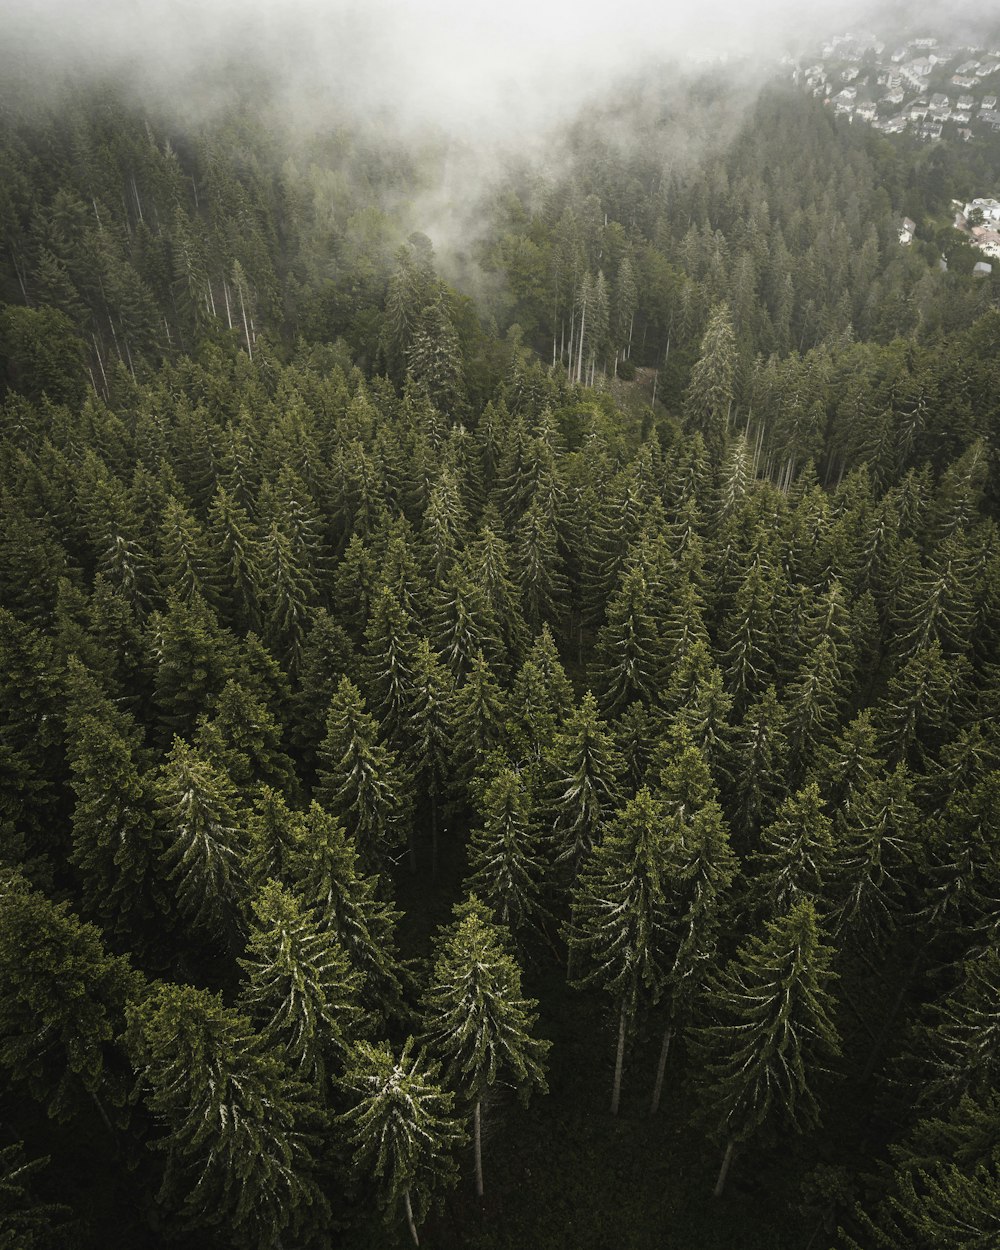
top-left (341, 1038), bottom-right (466, 1246)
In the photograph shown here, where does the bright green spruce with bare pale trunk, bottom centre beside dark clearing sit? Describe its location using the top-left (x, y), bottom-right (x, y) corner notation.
top-left (423, 895), bottom-right (550, 1198)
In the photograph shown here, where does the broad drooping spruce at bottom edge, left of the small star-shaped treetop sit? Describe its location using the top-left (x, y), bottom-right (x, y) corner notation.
top-left (129, 983), bottom-right (330, 1250)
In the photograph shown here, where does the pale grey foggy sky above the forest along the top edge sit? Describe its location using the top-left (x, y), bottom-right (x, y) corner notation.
top-left (0, 0), bottom-right (935, 130)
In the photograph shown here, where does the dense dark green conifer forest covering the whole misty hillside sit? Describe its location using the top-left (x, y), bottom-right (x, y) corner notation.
top-left (0, 56), bottom-right (1000, 1250)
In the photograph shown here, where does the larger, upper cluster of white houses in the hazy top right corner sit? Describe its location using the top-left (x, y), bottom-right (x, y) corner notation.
top-left (793, 33), bottom-right (1000, 141)
